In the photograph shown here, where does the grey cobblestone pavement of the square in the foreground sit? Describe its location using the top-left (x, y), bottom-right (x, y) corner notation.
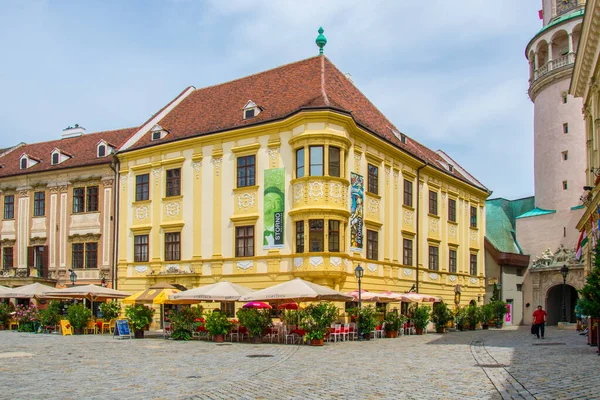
top-left (0, 327), bottom-right (600, 400)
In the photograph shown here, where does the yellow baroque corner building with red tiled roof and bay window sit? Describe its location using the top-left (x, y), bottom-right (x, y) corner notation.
top-left (117, 55), bottom-right (490, 310)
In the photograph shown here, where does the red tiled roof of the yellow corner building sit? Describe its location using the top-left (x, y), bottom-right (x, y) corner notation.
top-left (128, 56), bottom-right (487, 190)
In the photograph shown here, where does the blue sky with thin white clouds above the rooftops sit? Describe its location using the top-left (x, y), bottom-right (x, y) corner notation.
top-left (0, 0), bottom-right (541, 198)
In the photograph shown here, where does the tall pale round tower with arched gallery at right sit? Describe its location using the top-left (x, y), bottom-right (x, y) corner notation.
top-left (515, 0), bottom-right (586, 324)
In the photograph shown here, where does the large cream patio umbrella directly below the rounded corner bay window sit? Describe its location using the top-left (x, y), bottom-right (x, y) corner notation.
top-left (240, 278), bottom-right (353, 303)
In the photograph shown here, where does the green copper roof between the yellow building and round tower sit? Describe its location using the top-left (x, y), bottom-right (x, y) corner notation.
top-left (485, 197), bottom-right (535, 254)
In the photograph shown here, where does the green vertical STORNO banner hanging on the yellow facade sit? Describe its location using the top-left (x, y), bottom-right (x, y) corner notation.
top-left (263, 168), bottom-right (285, 249)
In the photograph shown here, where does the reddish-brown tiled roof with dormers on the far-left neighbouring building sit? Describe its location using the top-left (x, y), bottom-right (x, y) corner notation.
top-left (0, 128), bottom-right (138, 178)
